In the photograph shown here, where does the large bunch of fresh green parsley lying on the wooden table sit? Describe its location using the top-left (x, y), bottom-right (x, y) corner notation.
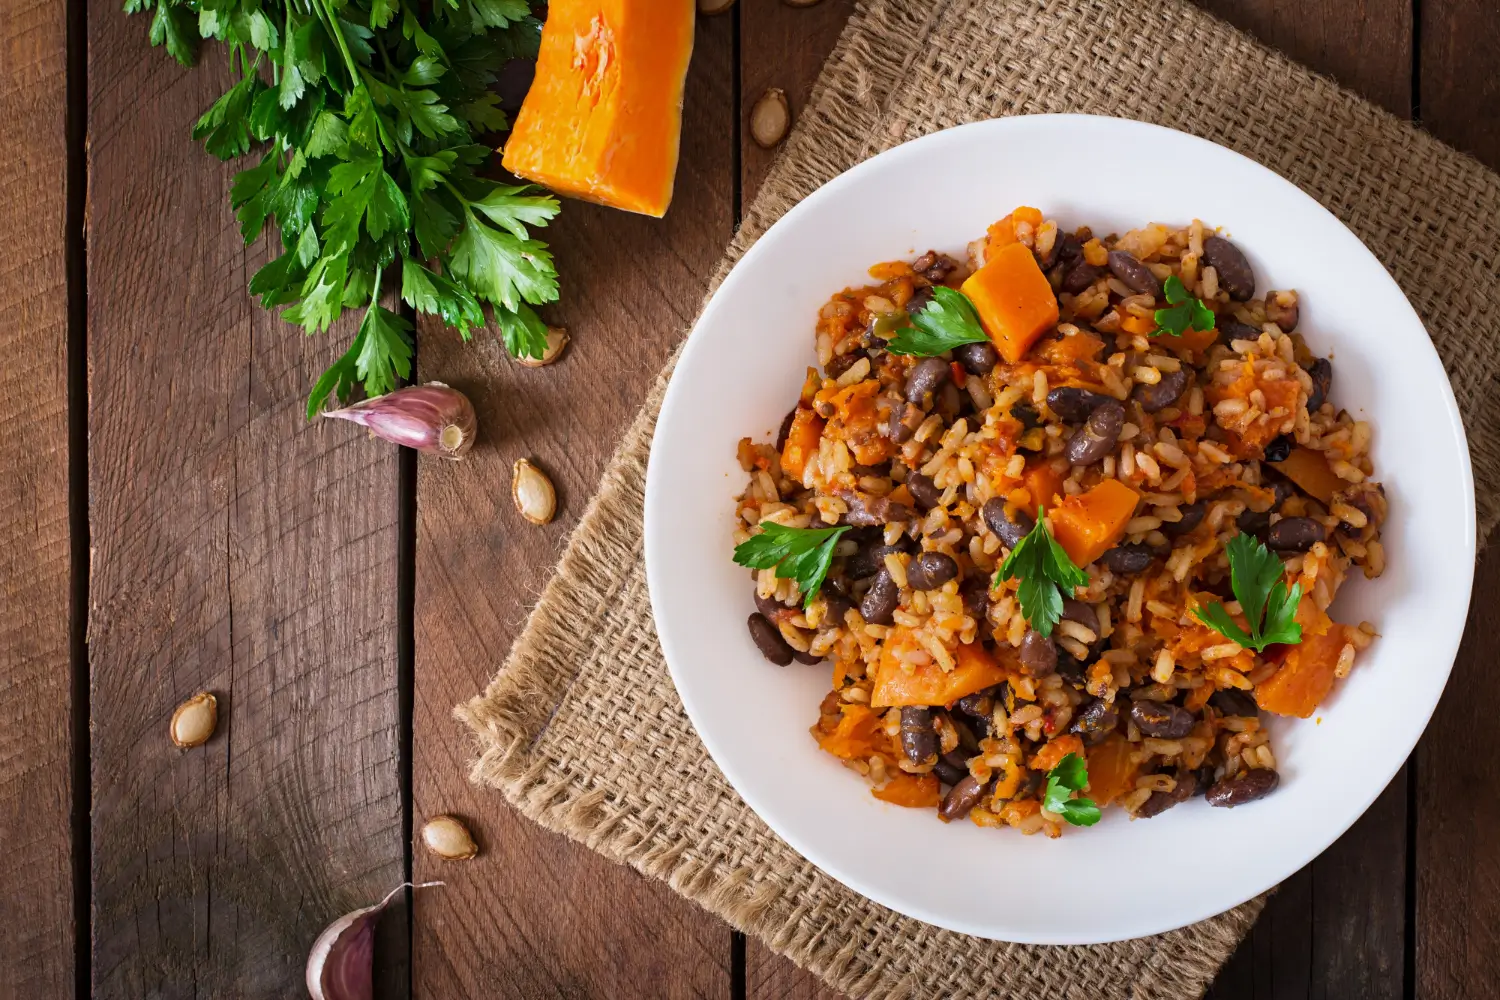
top-left (125, 0), bottom-right (558, 417)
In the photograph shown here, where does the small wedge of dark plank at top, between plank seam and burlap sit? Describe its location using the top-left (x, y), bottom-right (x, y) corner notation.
top-left (734, 0), bottom-right (855, 205)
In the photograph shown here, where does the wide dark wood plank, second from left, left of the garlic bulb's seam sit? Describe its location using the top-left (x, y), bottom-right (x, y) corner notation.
top-left (89, 13), bottom-right (407, 997)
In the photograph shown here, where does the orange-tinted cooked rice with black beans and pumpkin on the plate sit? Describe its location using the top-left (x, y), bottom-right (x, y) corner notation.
top-left (735, 210), bottom-right (1386, 837)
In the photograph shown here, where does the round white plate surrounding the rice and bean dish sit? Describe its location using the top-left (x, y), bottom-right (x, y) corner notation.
top-left (645, 115), bottom-right (1475, 945)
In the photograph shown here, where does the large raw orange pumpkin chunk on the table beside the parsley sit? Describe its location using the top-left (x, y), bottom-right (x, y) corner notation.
top-left (503, 0), bottom-right (695, 217)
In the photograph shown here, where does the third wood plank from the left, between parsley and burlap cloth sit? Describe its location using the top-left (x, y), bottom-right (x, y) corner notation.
top-left (413, 9), bottom-right (735, 999)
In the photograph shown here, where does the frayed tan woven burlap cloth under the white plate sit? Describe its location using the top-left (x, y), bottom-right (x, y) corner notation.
top-left (456, 0), bottom-right (1500, 1000)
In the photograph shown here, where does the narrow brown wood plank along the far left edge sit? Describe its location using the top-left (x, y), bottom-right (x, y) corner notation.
top-left (0, 0), bottom-right (75, 1000)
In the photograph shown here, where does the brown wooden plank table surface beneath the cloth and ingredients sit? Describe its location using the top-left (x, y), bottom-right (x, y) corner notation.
top-left (0, 0), bottom-right (1500, 1000)
